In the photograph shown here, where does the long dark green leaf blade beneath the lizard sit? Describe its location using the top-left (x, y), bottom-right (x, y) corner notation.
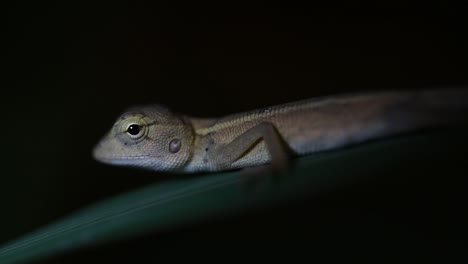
top-left (0, 128), bottom-right (467, 264)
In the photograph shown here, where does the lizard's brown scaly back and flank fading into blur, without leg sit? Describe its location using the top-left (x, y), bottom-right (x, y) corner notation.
top-left (191, 89), bottom-right (468, 168)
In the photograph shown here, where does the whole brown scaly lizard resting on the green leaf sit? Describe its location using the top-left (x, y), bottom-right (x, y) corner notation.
top-left (93, 89), bottom-right (468, 173)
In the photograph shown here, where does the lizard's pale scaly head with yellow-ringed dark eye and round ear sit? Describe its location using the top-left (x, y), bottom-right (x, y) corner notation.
top-left (93, 105), bottom-right (194, 171)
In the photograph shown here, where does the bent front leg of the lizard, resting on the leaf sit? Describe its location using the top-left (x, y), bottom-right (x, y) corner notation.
top-left (209, 122), bottom-right (290, 172)
